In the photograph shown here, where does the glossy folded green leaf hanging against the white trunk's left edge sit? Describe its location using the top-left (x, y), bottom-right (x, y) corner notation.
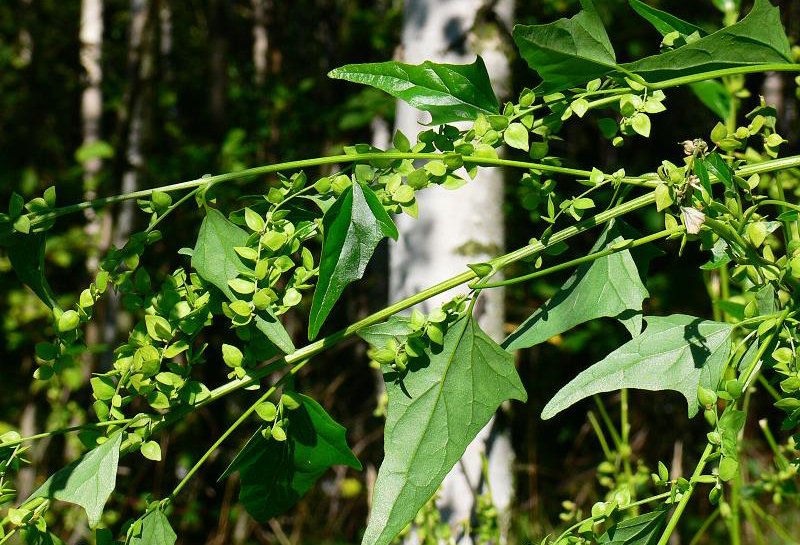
top-left (308, 183), bottom-right (397, 339)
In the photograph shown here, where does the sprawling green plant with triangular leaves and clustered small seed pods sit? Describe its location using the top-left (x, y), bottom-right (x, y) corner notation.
top-left (0, 0), bottom-right (800, 545)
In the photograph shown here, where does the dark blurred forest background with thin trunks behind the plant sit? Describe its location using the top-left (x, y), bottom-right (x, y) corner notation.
top-left (0, 0), bottom-right (800, 544)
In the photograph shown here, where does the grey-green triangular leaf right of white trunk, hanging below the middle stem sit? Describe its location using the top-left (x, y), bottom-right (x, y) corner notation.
top-left (503, 222), bottom-right (649, 350)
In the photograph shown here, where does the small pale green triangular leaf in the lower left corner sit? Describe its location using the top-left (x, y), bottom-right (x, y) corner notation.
top-left (31, 432), bottom-right (122, 526)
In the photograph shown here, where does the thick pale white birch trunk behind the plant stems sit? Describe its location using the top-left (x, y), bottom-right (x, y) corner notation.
top-left (389, 0), bottom-right (513, 542)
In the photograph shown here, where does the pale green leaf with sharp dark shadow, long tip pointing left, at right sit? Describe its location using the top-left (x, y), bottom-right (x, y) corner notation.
top-left (542, 314), bottom-right (733, 419)
